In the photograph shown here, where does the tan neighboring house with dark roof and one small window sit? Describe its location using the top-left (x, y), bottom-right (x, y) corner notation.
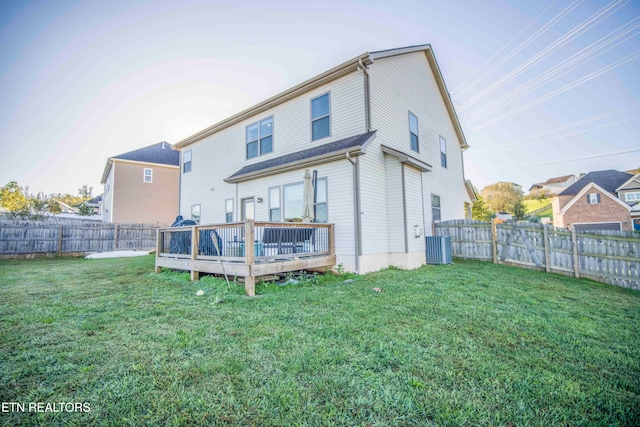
top-left (101, 142), bottom-right (180, 224)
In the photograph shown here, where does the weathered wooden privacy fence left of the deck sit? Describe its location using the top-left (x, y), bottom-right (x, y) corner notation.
top-left (0, 221), bottom-right (158, 256)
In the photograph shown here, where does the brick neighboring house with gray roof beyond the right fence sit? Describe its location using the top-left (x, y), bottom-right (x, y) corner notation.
top-left (552, 170), bottom-right (640, 231)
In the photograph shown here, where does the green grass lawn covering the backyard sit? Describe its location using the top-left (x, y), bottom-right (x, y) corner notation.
top-left (0, 257), bottom-right (640, 426)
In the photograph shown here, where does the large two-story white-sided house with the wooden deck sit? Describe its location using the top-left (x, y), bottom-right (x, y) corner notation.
top-left (175, 45), bottom-right (471, 273)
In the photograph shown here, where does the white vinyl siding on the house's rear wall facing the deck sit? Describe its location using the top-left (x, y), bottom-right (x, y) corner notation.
top-left (180, 72), bottom-right (366, 229)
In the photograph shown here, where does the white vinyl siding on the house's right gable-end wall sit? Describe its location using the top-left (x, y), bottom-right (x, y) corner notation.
top-left (360, 52), bottom-right (470, 254)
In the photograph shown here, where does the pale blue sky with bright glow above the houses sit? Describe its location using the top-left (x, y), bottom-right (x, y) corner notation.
top-left (0, 0), bottom-right (640, 195)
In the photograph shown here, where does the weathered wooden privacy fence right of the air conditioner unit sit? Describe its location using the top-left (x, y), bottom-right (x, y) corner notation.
top-left (435, 220), bottom-right (640, 289)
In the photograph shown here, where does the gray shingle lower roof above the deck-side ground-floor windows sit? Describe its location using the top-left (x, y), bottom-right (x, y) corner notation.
top-left (227, 131), bottom-right (376, 179)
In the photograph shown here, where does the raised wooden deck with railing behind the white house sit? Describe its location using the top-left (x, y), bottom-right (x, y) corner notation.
top-left (156, 221), bottom-right (336, 296)
